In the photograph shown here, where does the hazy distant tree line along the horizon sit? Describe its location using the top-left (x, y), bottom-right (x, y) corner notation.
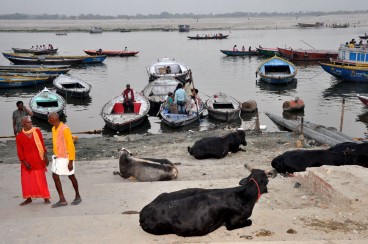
top-left (0, 10), bottom-right (368, 20)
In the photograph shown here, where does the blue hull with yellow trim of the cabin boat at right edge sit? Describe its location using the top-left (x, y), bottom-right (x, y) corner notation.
top-left (320, 60), bottom-right (368, 82)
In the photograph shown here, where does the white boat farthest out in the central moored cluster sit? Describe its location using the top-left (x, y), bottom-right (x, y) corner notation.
top-left (147, 57), bottom-right (189, 82)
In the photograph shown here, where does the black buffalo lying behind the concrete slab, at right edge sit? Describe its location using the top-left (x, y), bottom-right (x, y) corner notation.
top-left (271, 142), bottom-right (368, 173)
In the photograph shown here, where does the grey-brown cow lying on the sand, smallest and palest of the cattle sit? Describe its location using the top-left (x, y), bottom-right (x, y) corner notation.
top-left (117, 148), bottom-right (178, 181)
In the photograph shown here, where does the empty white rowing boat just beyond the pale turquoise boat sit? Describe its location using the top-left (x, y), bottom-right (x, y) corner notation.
top-left (53, 75), bottom-right (92, 98)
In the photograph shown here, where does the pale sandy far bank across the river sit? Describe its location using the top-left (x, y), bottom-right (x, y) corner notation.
top-left (0, 14), bottom-right (368, 32)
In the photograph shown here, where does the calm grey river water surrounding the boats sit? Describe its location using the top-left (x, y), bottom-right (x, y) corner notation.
top-left (0, 17), bottom-right (368, 137)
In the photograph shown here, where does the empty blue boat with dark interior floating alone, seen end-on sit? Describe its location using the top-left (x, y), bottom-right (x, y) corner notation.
top-left (256, 56), bottom-right (298, 84)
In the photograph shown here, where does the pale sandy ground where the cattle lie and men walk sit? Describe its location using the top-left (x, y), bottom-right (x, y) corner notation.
top-left (0, 130), bottom-right (368, 243)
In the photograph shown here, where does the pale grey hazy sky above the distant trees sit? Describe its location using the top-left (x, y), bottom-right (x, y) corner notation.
top-left (0, 0), bottom-right (368, 16)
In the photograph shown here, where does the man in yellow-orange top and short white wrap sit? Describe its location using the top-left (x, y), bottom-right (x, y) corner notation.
top-left (48, 112), bottom-right (82, 208)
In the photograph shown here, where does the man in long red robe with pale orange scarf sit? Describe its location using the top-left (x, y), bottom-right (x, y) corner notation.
top-left (16, 116), bottom-right (50, 206)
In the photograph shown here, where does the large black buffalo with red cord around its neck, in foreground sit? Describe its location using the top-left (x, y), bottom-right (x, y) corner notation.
top-left (139, 169), bottom-right (268, 236)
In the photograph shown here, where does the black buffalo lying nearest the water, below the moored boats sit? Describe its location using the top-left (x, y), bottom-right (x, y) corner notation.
top-left (188, 130), bottom-right (247, 159)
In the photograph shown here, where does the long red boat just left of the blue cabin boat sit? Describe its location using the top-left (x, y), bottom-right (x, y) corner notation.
top-left (277, 47), bottom-right (338, 61)
